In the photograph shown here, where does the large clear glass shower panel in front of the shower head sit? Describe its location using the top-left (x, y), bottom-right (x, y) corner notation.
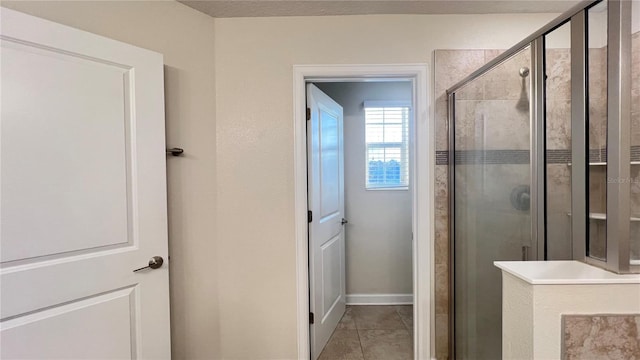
top-left (453, 47), bottom-right (537, 359)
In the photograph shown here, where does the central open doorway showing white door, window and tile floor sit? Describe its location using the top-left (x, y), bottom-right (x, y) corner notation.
top-left (307, 78), bottom-right (414, 360)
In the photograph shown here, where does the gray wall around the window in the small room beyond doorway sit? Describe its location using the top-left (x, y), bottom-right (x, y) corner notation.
top-left (316, 82), bottom-right (413, 295)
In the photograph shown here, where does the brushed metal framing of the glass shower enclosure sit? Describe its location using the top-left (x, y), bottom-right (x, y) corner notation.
top-left (447, 0), bottom-right (640, 359)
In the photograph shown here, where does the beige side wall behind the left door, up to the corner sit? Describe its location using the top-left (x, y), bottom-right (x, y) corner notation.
top-left (2, 1), bottom-right (220, 359)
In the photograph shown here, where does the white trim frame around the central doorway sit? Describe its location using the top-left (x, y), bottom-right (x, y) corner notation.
top-left (293, 64), bottom-right (435, 359)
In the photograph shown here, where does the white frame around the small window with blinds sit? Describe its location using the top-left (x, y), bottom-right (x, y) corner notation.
top-left (363, 100), bottom-right (413, 191)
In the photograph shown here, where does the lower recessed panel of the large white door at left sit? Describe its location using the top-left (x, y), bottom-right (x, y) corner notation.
top-left (0, 288), bottom-right (136, 359)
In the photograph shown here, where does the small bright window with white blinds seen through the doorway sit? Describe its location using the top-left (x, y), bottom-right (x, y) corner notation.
top-left (364, 101), bottom-right (411, 189)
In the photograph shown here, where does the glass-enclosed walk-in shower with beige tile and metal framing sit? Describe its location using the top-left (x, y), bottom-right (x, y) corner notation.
top-left (447, 0), bottom-right (640, 359)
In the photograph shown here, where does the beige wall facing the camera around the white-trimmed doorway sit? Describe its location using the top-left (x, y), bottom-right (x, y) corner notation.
top-left (215, 14), bottom-right (554, 359)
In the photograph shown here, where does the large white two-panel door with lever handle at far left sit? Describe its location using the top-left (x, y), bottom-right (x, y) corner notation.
top-left (0, 8), bottom-right (170, 359)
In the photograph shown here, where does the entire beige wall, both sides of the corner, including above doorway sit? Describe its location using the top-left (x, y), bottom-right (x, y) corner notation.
top-left (2, 1), bottom-right (553, 359)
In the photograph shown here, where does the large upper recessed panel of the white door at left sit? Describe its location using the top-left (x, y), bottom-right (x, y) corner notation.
top-left (1, 40), bottom-right (132, 263)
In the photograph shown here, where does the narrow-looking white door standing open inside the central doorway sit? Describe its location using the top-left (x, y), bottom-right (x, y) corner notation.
top-left (307, 84), bottom-right (346, 360)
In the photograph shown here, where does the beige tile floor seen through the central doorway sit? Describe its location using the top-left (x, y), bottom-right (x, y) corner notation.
top-left (319, 305), bottom-right (413, 360)
